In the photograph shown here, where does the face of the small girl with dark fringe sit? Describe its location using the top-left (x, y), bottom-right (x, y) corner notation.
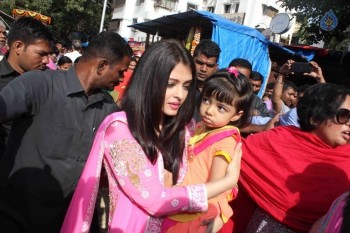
top-left (199, 96), bottom-right (243, 128)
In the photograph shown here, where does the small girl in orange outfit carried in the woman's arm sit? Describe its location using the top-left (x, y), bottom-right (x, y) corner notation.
top-left (162, 67), bottom-right (252, 233)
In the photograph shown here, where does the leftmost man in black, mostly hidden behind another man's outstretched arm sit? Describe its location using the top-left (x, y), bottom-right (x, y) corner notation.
top-left (0, 17), bottom-right (53, 160)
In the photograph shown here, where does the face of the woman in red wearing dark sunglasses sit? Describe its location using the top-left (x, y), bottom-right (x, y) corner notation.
top-left (312, 95), bottom-right (350, 147)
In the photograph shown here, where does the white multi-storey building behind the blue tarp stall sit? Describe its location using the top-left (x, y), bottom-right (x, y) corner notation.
top-left (108, 0), bottom-right (298, 44)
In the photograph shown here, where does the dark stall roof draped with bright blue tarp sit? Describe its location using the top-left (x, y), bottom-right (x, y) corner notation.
top-left (129, 11), bottom-right (288, 96)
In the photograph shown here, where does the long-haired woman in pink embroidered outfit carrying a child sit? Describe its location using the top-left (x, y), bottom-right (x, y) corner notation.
top-left (61, 40), bottom-right (241, 233)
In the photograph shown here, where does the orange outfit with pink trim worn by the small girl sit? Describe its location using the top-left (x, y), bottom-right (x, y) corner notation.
top-left (165, 123), bottom-right (240, 233)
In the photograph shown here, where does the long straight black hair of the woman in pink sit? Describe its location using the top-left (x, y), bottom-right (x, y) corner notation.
top-left (121, 40), bottom-right (195, 184)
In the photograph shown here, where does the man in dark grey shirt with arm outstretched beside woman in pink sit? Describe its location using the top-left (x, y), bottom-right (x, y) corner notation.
top-left (0, 32), bottom-right (132, 232)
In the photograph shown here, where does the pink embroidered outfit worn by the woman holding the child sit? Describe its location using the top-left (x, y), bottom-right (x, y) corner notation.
top-left (61, 112), bottom-right (208, 233)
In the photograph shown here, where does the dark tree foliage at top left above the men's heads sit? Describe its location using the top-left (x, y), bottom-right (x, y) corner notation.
top-left (0, 0), bottom-right (111, 40)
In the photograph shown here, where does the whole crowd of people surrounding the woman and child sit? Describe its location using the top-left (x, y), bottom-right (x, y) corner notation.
top-left (0, 17), bottom-right (350, 233)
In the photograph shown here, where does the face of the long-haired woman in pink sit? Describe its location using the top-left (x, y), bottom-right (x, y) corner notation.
top-left (163, 63), bottom-right (192, 116)
